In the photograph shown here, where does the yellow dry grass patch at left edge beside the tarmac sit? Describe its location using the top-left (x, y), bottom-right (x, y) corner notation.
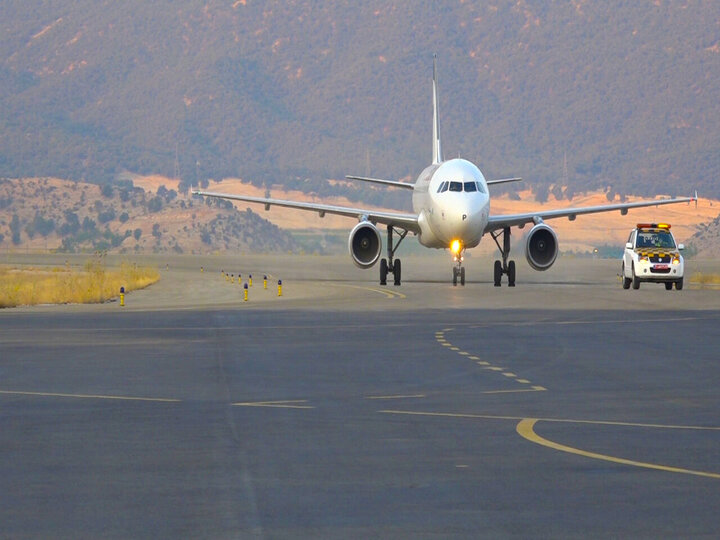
top-left (0, 260), bottom-right (160, 308)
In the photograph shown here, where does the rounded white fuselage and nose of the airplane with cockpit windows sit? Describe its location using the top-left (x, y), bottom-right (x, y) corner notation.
top-left (413, 159), bottom-right (490, 249)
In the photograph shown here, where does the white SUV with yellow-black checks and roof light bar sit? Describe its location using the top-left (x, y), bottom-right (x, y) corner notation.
top-left (622, 223), bottom-right (685, 291)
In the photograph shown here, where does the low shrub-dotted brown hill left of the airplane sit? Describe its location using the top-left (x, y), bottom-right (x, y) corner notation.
top-left (0, 178), bottom-right (297, 253)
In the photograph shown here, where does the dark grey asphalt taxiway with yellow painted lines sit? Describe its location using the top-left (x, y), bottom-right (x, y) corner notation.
top-left (0, 258), bottom-right (720, 538)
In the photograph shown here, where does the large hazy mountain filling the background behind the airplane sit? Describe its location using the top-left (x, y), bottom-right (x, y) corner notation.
top-left (0, 0), bottom-right (720, 198)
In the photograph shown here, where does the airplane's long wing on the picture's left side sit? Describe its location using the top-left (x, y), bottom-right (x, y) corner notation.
top-left (191, 189), bottom-right (420, 233)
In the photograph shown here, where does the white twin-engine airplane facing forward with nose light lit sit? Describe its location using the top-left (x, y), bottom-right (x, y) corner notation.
top-left (191, 56), bottom-right (697, 287)
